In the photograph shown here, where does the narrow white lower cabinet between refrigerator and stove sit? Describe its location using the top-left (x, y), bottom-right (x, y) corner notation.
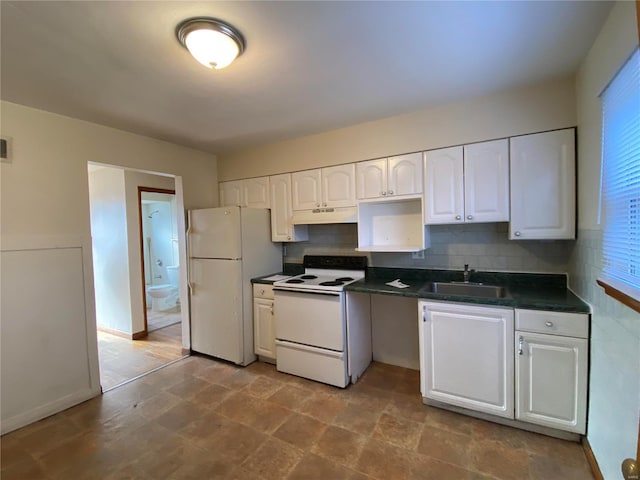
top-left (253, 284), bottom-right (276, 361)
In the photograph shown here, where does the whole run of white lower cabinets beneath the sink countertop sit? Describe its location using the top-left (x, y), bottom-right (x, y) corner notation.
top-left (419, 300), bottom-right (589, 435)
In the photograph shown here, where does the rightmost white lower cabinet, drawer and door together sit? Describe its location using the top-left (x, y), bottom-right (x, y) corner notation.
top-left (515, 310), bottom-right (589, 434)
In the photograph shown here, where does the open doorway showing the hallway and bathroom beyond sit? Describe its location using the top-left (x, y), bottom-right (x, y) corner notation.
top-left (88, 164), bottom-right (188, 391)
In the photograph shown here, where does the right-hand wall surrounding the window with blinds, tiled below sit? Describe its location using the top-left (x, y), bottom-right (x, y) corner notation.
top-left (570, 2), bottom-right (640, 480)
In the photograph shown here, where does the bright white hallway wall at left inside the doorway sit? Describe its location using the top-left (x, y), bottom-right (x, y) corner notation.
top-left (89, 167), bottom-right (134, 335)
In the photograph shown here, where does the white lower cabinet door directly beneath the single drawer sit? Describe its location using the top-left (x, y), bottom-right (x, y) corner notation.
top-left (515, 332), bottom-right (588, 434)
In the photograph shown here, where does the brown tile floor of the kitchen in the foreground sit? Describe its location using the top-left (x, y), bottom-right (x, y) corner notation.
top-left (1, 356), bottom-right (593, 480)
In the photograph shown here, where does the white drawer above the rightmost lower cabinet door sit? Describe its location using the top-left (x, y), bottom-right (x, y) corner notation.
top-left (516, 309), bottom-right (589, 338)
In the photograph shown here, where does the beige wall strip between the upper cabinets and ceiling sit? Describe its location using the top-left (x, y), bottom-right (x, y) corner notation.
top-left (218, 78), bottom-right (576, 181)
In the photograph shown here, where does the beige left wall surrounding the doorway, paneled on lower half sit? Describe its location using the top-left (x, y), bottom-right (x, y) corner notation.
top-left (0, 102), bottom-right (218, 432)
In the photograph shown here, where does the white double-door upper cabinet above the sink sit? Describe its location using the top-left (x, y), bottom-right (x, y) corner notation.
top-left (424, 139), bottom-right (509, 224)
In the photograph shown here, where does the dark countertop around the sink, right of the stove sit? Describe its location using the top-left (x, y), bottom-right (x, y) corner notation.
top-left (345, 267), bottom-right (590, 313)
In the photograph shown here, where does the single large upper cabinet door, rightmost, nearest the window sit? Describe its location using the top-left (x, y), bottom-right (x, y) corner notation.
top-left (509, 128), bottom-right (576, 240)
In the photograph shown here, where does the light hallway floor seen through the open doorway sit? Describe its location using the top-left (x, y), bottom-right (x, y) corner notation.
top-left (98, 323), bottom-right (183, 390)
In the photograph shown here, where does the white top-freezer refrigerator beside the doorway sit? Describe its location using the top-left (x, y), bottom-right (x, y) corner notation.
top-left (187, 207), bottom-right (282, 365)
